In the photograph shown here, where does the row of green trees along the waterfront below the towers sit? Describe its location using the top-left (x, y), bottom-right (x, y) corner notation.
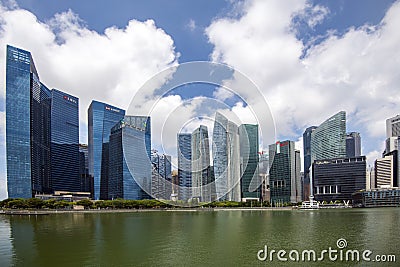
top-left (0, 198), bottom-right (278, 209)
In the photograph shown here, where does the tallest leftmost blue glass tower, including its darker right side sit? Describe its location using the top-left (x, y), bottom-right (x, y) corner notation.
top-left (6, 46), bottom-right (51, 198)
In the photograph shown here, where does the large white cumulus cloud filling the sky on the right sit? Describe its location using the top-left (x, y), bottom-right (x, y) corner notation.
top-left (206, 0), bottom-right (400, 164)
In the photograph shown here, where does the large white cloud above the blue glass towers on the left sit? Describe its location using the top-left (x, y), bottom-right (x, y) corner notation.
top-left (0, 3), bottom-right (179, 142)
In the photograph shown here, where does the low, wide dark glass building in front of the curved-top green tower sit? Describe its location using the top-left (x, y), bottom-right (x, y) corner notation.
top-left (312, 156), bottom-right (367, 203)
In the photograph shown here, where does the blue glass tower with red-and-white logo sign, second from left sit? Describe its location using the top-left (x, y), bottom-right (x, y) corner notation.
top-left (51, 89), bottom-right (81, 192)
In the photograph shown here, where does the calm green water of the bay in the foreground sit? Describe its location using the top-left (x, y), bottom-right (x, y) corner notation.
top-left (0, 208), bottom-right (400, 266)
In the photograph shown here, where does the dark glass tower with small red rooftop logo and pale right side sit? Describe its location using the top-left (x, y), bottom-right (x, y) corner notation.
top-left (269, 140), bottom-right (302, 205)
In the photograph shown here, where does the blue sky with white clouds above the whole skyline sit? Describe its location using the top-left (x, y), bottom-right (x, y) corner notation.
top-left (0, 0), bottom-right (400, 198)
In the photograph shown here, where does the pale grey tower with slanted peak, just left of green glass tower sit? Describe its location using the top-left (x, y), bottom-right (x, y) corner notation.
top-left (213, 112), bottom-right (241, 201)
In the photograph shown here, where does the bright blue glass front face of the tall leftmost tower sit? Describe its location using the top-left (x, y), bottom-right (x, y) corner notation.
top-left (6, 46), bottom-right (34, 198)
